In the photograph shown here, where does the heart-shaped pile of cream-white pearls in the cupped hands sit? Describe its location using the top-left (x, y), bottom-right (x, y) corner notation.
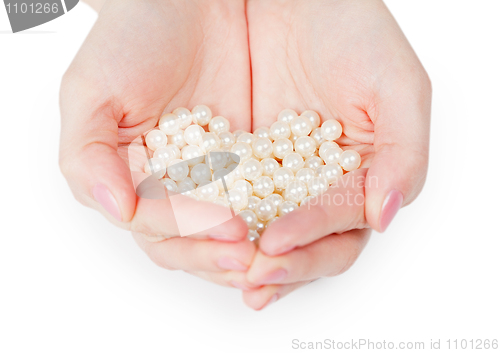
top-left (144, 105), bottom-right (361, 241)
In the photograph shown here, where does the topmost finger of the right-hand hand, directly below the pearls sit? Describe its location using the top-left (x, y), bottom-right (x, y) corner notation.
top-left (259, 169), bottom-right (366, 256)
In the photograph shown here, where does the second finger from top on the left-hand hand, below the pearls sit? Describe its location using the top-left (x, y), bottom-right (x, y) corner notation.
top-left (132, 232), bottom-right (256, 272)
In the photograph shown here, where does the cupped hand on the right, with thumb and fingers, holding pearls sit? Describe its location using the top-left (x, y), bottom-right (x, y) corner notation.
top-left (244, 0), bottom-right (431, 309)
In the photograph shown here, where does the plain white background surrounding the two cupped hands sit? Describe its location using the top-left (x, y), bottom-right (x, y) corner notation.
top-left (0, 0), bottom-right (500, 353)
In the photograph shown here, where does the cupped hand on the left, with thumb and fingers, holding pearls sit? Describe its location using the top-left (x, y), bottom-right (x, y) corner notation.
top-left (60, 0), bottom-right (255, 286)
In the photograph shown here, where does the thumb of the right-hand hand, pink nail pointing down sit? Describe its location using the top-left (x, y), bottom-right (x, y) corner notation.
top-left (365, 72), bottom-right (431, 232)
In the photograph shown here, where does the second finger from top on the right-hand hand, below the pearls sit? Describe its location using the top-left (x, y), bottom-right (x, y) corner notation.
top-left (247, 229), bottom-right (371, 285)
